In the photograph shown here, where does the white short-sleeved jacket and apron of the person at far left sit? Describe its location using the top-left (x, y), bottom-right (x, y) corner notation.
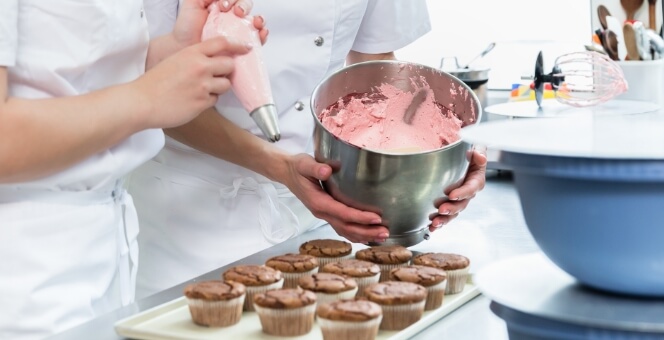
top-left (0, 0), bottom-right (164, 339)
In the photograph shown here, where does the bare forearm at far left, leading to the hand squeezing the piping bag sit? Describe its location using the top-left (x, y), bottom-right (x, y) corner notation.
top-left (0, 67), bottom-right (149, 183)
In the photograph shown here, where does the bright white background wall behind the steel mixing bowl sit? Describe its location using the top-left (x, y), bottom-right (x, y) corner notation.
top-left (396, 0), bottom-right (592, 89)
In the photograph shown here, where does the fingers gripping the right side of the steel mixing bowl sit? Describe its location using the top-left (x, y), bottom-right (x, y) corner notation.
top-left (429, 147), bottom-right (487, 232)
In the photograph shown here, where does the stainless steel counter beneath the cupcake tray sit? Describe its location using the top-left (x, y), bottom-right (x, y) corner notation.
top-left (52, 174), bottom-right (538, 340)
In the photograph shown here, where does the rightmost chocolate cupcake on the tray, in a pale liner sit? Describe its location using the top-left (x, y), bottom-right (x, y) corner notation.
top-left (413, 253), bottom-right (470, 295)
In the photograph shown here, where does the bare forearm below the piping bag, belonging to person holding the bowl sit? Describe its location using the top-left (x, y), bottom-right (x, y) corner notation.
top-left (164, 108), bottom-right (289, 182)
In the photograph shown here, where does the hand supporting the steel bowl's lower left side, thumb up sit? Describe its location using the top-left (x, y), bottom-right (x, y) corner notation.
top-left (282, 154), bottom-right (389, 244)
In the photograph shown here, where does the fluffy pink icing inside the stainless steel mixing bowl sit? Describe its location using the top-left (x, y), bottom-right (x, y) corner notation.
top-left (318, 84), bottom-right (462, 152)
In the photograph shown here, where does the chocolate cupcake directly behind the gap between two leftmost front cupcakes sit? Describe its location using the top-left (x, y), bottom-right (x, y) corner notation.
top-left (222, 265), bottom-right (284, 311)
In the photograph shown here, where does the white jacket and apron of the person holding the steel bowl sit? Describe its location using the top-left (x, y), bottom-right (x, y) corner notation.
top-left (129, 0), bottom-right (430, 297)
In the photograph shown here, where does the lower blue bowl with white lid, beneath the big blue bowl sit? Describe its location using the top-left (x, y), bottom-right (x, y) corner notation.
top-left (473, 252), bottom-right (664, 340)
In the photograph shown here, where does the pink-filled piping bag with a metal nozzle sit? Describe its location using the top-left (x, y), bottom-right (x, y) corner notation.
top-left (201, 2), bottom-right (281, 142)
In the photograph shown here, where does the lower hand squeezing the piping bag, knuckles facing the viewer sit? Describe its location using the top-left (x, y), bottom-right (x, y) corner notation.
top-left (133, 37), bottom-right (251, 128)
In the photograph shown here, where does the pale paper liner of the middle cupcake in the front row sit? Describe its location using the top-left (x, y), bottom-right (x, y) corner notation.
top-left (254, 303), bottom-right (316, 336)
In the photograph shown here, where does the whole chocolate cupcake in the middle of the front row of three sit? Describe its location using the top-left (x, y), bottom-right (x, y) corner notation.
top-left (254, 288), bottom-right (316, 336)
